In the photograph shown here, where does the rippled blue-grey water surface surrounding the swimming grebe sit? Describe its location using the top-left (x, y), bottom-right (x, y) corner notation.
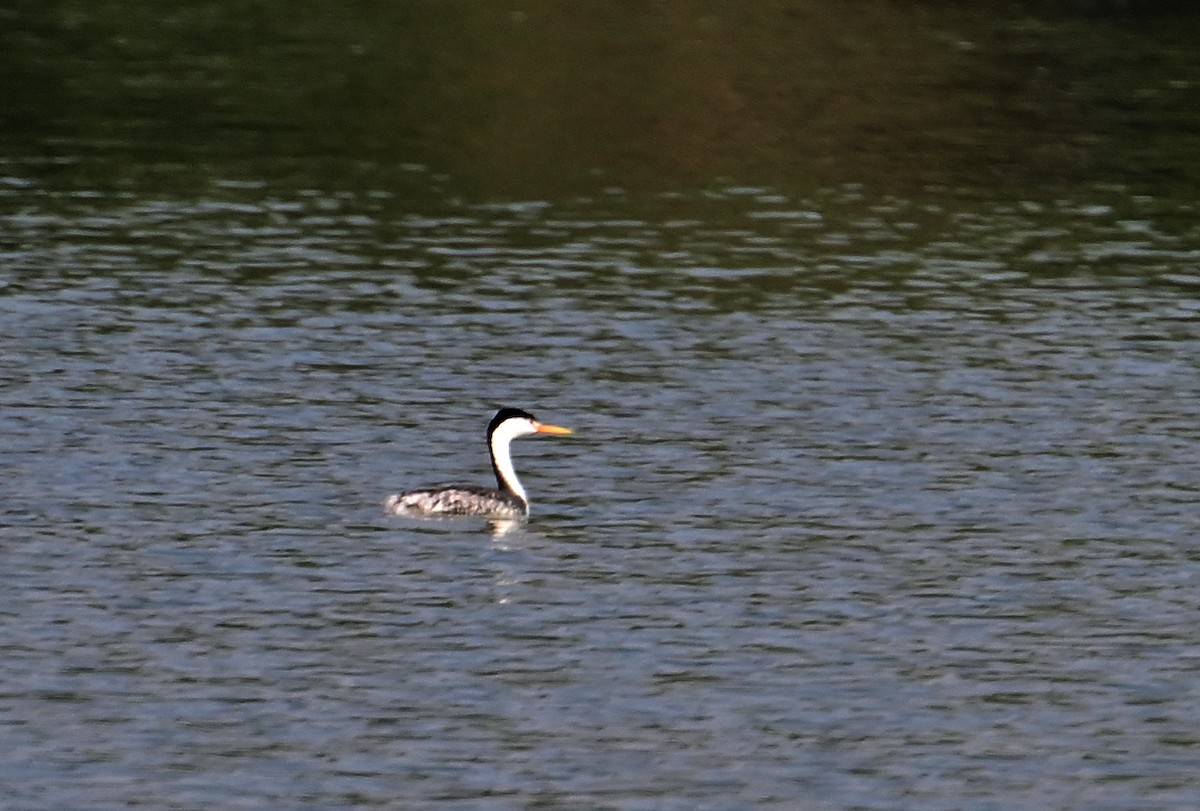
top-left (0, 184), bottom-right (1200, 810)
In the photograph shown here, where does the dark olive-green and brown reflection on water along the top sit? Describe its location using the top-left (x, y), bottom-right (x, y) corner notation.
top-left (0, 0), bottom-right (1200, 197)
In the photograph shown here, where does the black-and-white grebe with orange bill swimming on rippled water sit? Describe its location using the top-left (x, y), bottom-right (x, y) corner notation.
top-left (384, 408), bottom-right (571, 518)
